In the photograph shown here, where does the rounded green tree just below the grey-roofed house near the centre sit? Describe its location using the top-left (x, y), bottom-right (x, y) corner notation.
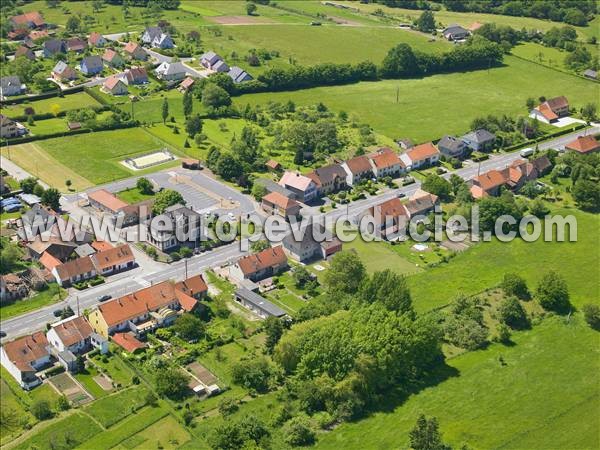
top-left (323, 251), bottom-right (367, 294)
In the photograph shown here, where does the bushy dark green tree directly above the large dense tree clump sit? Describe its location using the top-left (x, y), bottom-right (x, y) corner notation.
top-left (359, 269), bottom-right (412, 313)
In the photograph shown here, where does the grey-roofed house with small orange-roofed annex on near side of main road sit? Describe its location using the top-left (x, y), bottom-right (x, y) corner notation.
top-left (282, 224), bottom-right (342, 262)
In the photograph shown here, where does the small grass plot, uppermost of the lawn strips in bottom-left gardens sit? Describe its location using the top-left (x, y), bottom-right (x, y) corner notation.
top-left (85, 387), bottom-right (148, 428)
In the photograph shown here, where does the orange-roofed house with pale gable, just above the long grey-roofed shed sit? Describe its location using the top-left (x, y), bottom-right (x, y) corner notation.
top-left (229, 245), bottom-right (288, 282)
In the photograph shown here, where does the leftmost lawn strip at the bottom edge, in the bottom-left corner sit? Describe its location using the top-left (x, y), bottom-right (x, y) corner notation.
top-left (13, 411), bottom-right (102, 450)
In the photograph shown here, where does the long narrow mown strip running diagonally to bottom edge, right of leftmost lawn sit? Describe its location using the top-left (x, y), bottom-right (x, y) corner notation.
top-left (77, 407), bottom-right (167, 450)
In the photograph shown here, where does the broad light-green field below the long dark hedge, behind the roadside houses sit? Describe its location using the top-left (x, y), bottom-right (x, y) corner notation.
top-left (235, 56), bottom-right (600, 142)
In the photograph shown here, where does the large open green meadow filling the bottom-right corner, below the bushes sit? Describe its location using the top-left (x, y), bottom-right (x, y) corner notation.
top-left (316, 316), bottom-right (600, 449)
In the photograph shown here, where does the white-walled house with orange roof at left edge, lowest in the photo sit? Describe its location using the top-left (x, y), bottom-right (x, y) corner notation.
top-left (0, 331), bottom-right (50, 390)
